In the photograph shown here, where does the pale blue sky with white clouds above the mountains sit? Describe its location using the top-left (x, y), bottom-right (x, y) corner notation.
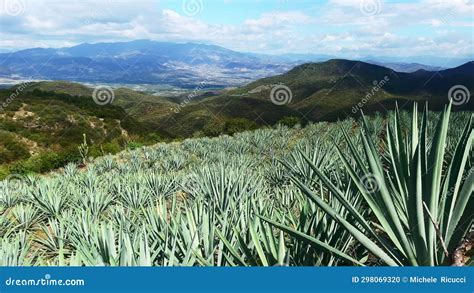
top-left (0, 0), bottom-right (474, 58)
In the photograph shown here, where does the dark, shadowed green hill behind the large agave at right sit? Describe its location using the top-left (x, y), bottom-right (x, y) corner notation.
top-left (231, 60), bottom-right (474, 120)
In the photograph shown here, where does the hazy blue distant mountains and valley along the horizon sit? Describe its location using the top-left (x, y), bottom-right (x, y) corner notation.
top-left (0, 40), bottom-right (464, 88)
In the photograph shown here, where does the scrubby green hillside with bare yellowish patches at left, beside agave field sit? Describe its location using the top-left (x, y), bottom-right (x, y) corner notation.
top-left (0, 88), bottom-right (165, 176)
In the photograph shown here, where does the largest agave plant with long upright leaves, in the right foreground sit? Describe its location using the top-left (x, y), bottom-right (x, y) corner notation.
top-left (267, 105), bottom-right (474, 266)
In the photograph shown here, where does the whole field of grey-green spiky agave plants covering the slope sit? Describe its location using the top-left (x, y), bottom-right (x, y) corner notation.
top-left (0, 105), bottom-right (474, 266)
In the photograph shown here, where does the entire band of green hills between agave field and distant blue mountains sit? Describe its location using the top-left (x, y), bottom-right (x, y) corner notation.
top-left (0, 57), bottom-right (474, 177)
